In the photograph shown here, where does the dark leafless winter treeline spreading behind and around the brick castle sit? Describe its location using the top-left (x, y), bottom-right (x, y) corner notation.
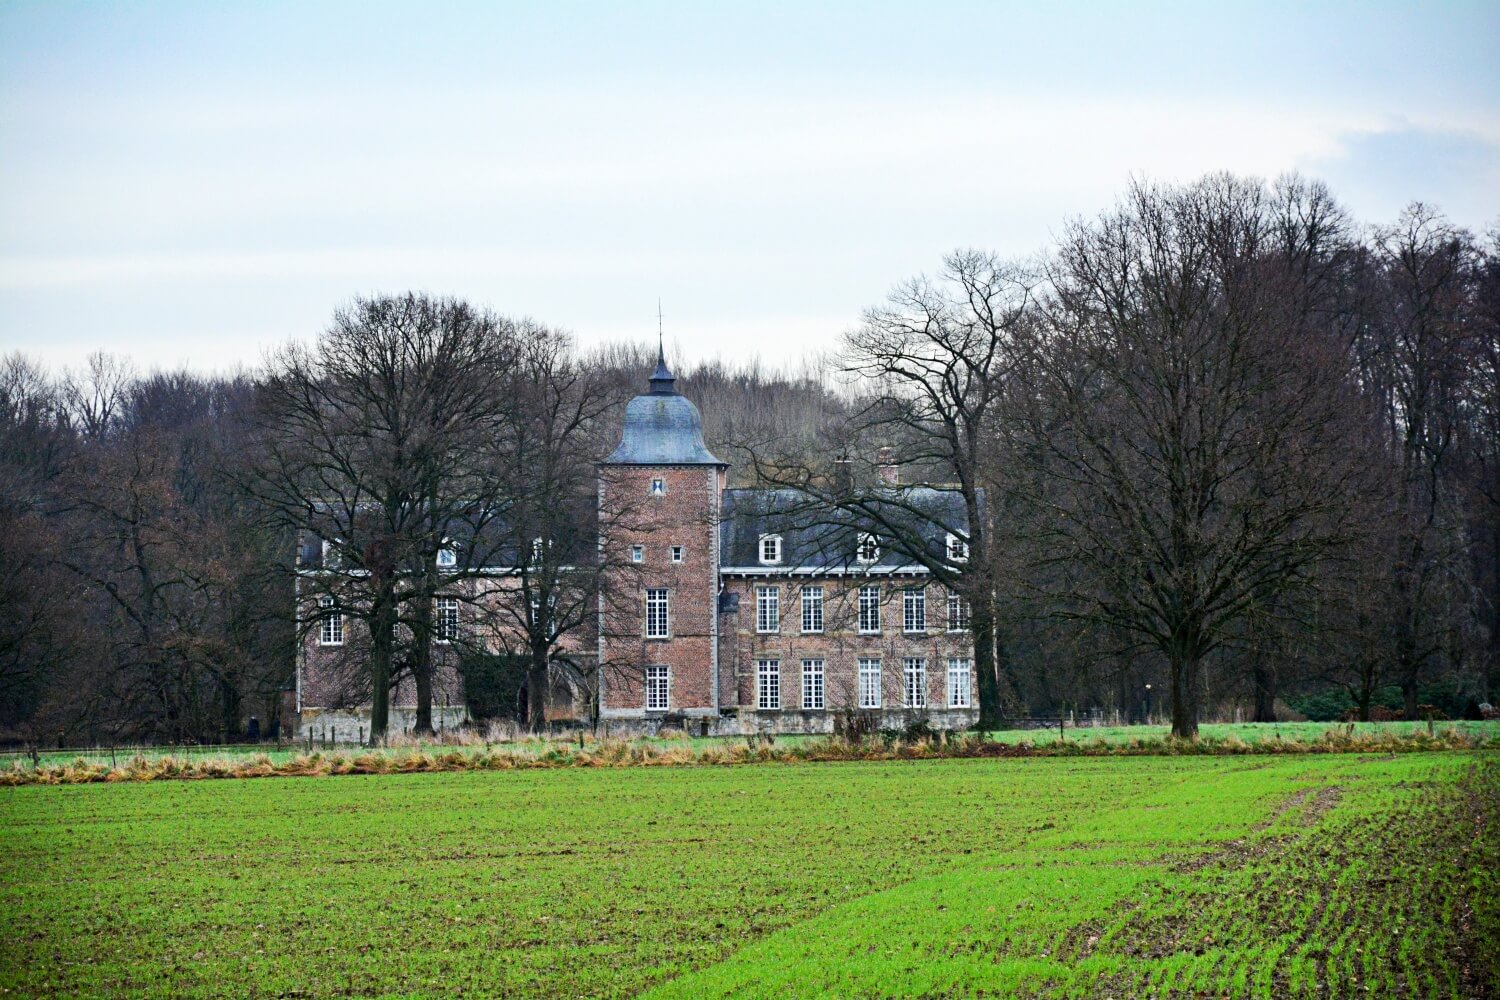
top-left (0, 175), bottom-right (1500, 742)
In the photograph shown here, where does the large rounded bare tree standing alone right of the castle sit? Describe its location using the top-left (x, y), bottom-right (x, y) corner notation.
top-left (1017, 175), bottom-right (1361, 738)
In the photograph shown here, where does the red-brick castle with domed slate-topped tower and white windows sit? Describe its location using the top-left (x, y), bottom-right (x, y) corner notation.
top-left (297, 350), bottom-right (978, 738)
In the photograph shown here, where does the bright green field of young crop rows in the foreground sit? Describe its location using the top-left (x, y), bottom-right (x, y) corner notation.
top-left (0, 751), bottom-right (1500, 997)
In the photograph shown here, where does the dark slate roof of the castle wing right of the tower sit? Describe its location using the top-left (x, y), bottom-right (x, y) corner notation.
top-left (719, 486), bottom-right (969, 573)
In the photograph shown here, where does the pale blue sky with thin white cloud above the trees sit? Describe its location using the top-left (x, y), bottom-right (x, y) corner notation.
top-left (0, 0), bottom-right (1500, 370)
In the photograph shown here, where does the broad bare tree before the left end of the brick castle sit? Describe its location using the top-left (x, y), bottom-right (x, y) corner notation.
top-left (246, 294), bottom-right (513, 741)
